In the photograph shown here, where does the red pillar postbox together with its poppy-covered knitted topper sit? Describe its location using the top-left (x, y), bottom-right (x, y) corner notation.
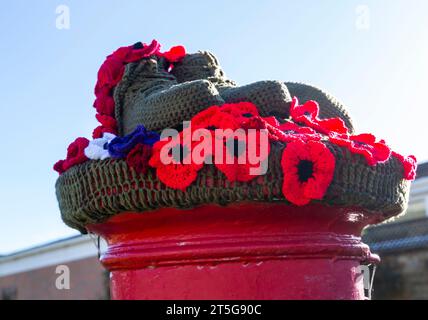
top-left (54, 40), bottom-right (416, 299)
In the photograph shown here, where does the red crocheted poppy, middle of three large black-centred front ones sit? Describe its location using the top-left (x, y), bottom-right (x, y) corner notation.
top-left (214, 130), bottom-right (270, 182)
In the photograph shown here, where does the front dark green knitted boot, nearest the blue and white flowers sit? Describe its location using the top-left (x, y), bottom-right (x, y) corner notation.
top-left (114, 56), bottom-right (224, 135)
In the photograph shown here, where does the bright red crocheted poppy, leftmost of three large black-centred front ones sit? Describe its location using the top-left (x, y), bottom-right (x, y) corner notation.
top-left (149, 133), bottom-right (203, 191)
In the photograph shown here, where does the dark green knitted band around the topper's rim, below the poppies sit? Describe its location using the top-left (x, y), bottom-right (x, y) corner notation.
top-left (56, 142), bottom-right (410, 232)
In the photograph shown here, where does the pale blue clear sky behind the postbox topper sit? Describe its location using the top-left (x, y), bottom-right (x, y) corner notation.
top-left (0, 0), bottom-right (428, 254)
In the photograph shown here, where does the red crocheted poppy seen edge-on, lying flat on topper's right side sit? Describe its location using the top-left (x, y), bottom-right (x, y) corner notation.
top-left (329, 133), bottom-right (391, 166)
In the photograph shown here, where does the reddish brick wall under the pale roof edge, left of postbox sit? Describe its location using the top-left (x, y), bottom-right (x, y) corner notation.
top-left (0, 257), bottom-right (109, 300)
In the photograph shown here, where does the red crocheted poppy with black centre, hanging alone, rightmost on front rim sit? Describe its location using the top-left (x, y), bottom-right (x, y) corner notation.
top-left (281, 140), bottom-right (335, 206)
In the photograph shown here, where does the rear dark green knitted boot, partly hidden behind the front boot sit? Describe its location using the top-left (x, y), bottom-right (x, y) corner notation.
top-left (172, 51), bottom-right (291, 118)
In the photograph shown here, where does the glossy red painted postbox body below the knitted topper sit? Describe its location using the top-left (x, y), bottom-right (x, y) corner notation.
top-left (88, 203), bottom-right (381, 299)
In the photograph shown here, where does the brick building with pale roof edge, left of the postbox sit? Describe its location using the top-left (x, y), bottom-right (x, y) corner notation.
top-left (0, 236), bottom-right (109, 300)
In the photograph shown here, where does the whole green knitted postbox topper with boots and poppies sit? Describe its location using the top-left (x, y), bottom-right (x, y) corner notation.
top-left (54, 41), bottom-right (416, 232)
